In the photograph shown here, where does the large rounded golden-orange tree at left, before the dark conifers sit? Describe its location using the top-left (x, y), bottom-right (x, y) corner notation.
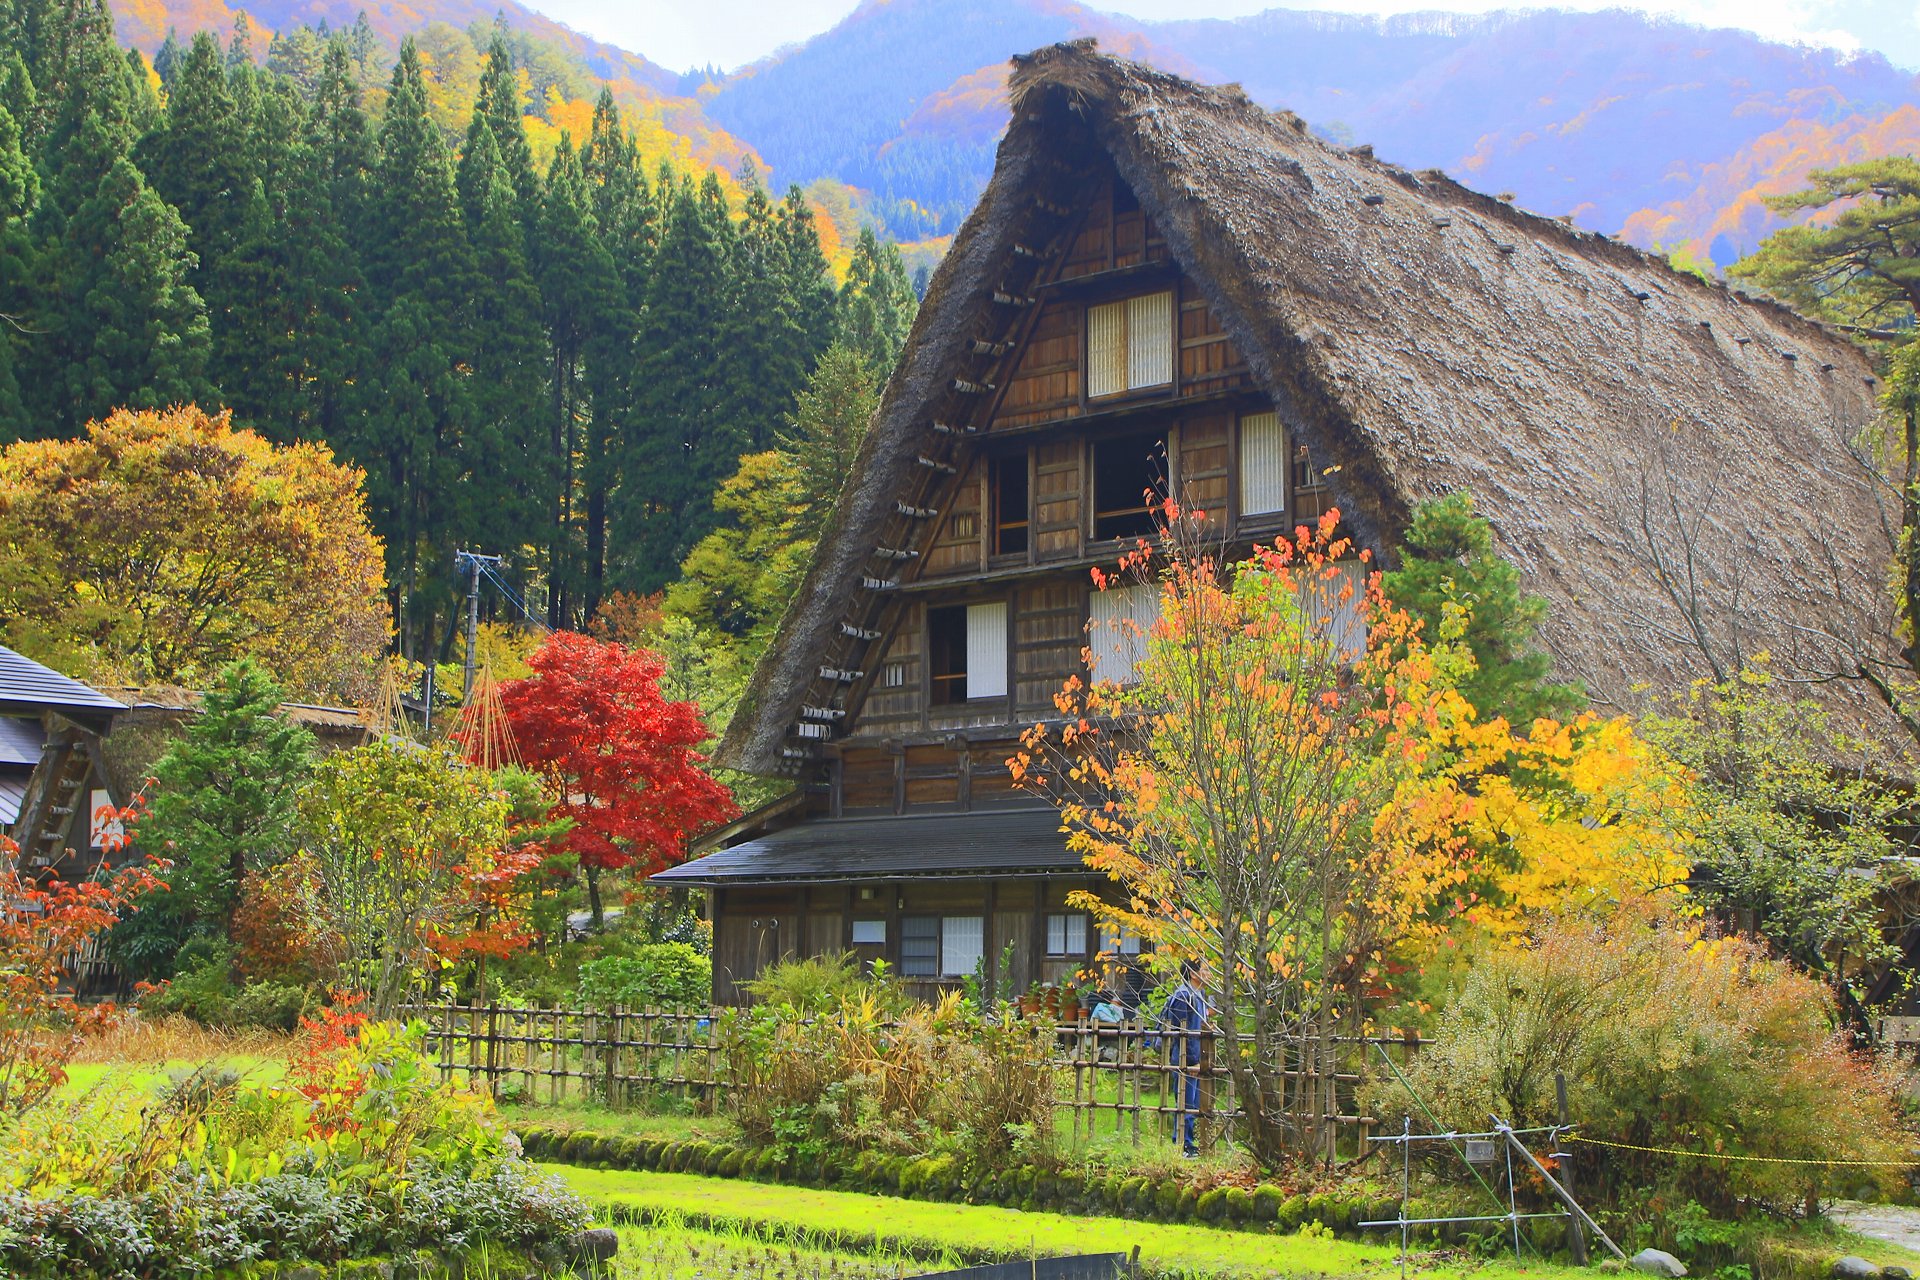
top-left (0, 405), bottom-right (388, 699)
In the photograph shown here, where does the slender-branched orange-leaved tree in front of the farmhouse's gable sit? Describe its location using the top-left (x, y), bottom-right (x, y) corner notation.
top-left (1012, 503), bottom-right (1465, 1161)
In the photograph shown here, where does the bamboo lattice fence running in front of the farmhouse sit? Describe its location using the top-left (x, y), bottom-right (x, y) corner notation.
top-left (403, 1004), bottom-right (1421, 1148)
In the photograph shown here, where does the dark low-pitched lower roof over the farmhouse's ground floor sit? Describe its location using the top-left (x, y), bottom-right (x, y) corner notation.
top-left (653, 810), bottom-right (1083, 885)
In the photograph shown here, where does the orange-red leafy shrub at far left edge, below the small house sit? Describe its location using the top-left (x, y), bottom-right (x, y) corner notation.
top-left (0, 832), bottom-right (167, 1115)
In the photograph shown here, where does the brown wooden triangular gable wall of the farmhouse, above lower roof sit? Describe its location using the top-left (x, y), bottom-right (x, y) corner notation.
top-left (829, 165), bottom-right (1344, 812)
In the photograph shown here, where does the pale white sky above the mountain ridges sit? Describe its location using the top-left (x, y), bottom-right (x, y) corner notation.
top-left (530, 0), bottom-right (1920, 71)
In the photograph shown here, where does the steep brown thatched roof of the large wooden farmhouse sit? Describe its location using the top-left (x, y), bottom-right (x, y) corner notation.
top-left (716, 42), bottom-right (1889, 771)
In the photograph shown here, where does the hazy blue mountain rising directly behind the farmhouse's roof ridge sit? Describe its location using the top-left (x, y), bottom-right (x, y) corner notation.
top-left (703, 0), bottom-right (1920, 260)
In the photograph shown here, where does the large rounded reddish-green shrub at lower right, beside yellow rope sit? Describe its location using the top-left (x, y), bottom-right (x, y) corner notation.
top-left (1375, 910), bottom-right (1907, 1213)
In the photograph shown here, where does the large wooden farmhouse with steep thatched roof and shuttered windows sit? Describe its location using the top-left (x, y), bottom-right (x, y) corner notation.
top-left (655, 42), bottom-right (1897, 1002)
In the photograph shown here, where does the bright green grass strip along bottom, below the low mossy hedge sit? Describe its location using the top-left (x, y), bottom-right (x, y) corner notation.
top-left (547, 1165), bottom-right (1574, 1280)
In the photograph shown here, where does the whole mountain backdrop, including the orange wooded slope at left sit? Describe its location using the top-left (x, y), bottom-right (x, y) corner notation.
top-left (115, 0), bottom-right (1920, 265)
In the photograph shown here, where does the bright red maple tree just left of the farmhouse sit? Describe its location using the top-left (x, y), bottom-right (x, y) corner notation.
top-left (501, 631), bottom-right (737, 925)
